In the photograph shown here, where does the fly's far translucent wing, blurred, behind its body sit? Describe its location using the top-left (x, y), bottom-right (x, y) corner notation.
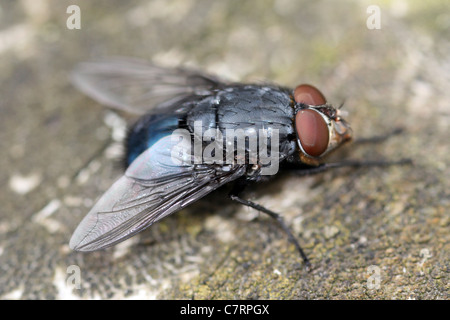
top-left (71, 58), bottom-right (225, 115)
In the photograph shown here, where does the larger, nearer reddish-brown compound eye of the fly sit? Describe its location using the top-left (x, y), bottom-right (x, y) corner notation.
top-left (295, 109), bottom-right (329, 157)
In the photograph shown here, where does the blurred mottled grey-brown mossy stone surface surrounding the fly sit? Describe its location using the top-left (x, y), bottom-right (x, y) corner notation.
top-left (0, 0), bottom-right (450, 299)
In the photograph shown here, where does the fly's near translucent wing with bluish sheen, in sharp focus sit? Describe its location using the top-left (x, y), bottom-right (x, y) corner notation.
top-left (69, 131), bottom-right (245, 251)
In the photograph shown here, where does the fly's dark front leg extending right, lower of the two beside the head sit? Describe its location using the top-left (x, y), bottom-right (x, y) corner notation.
top-left (293, 159), bottom-right (412, 176)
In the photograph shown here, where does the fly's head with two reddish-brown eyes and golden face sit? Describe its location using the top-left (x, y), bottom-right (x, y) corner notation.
top-left (294, 84), bottom-right (352, 166)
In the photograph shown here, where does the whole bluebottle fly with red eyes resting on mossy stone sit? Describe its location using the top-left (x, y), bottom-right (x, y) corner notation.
top-left (70, 58), bottom-right (410, 267)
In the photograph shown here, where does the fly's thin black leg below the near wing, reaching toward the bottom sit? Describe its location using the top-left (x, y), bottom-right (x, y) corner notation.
top-left (229, 180), bottom-right (311, 271)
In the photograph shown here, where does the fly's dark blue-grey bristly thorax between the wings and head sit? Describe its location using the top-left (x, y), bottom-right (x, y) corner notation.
top-left (176, 85), bottom-right (296, 174)
